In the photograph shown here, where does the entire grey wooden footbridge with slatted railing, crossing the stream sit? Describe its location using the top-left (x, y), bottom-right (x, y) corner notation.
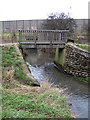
top-left (19, 30), bottom-right (69, 48)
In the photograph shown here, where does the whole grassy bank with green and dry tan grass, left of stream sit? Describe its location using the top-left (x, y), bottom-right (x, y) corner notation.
top-left (2, 46), bottom-right (72, 118)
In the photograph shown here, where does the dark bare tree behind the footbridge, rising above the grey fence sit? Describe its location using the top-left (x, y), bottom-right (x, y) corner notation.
top-left (42, 12), bottom-right (76, 32)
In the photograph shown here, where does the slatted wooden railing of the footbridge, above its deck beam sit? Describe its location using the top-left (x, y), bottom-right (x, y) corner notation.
top-left (19, 29), bottom-right (69, 45)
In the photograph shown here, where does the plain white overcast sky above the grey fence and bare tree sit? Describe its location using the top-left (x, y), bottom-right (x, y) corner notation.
top-left (0, 0), bottom-right (90, 21)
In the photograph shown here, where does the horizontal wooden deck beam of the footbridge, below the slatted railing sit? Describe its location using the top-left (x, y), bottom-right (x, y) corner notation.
top-left (20, 42), bottom-right (65, 48)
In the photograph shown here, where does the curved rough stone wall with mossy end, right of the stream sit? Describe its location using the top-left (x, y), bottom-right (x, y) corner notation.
top-left (55, 43), bottom-right (90, 77)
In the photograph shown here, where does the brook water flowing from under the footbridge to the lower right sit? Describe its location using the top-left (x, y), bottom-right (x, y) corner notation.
top-left (25, 49), bottom-right (88, 118)
